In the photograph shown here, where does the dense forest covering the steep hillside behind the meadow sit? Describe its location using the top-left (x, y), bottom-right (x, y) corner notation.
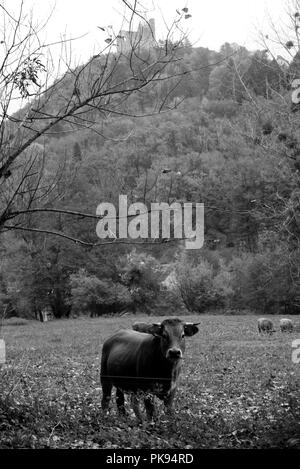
top-left (0, 31), bottom-right (300, 318)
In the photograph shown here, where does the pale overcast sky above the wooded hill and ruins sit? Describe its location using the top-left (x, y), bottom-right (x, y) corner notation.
top-left (0, 0), bottom-right (286, 62)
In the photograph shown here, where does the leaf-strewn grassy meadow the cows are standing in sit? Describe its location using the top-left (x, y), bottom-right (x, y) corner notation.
top-left (0, 316), bottom-right (300, 449)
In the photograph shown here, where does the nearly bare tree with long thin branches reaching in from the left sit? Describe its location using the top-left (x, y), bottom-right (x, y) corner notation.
top-left (0, 0), bottom-right (197, 245)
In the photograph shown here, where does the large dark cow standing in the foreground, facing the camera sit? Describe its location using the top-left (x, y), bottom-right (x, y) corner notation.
top-left (100, 318), bottom-right (199, 420)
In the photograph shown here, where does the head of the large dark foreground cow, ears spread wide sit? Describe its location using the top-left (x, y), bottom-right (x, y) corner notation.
top-left (148, 319), bottom-right (199, 361)
